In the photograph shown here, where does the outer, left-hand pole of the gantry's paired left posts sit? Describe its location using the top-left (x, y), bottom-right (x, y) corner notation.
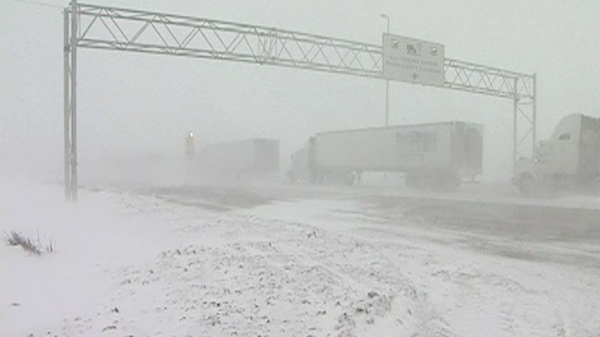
top-left (63, 8), bottom-right (71, 200)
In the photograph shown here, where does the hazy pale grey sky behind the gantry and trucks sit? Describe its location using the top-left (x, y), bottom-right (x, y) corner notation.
top-left (0, 0), bottom-right (600, 181)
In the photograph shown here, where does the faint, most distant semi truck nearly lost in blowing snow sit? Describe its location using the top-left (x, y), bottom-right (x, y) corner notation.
top-left (197, 138), bottom-right (279, 177)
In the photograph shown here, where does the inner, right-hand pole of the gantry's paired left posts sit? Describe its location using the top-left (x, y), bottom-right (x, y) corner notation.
top-left (71, 0), bottom-right (78, 200)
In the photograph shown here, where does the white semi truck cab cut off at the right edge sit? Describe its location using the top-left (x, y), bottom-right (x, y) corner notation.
top-left (512, 114), bottom-right (600, 196)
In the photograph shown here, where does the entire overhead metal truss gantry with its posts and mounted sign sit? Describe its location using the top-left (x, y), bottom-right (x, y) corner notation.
top-left (64, 0), bottom-right (536, 200)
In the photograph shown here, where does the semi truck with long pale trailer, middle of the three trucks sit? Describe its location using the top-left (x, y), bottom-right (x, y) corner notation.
top-left (288, 121), bottom-right (483, 189)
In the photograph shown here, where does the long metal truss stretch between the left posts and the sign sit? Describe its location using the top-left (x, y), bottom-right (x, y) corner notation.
top-left (77, 4), bottom-right (382, 77)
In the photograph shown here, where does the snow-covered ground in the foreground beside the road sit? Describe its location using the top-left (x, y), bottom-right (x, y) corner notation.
top-left (0, 179), bottom-right (600, 336)
